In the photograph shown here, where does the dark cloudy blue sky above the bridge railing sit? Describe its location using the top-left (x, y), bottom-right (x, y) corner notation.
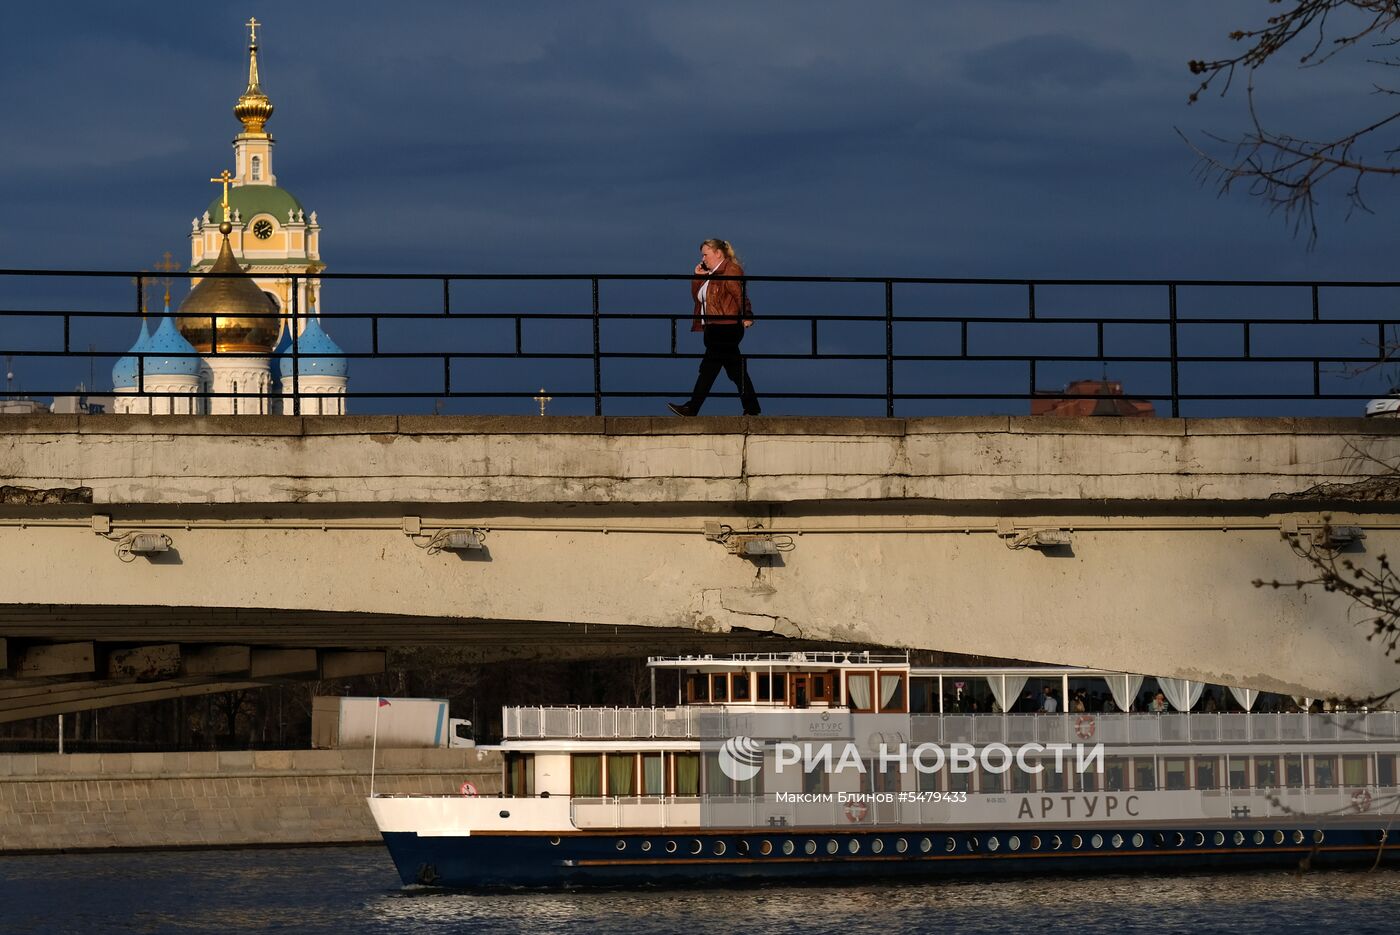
top-left (0, 0), bottom-right (1400, 411)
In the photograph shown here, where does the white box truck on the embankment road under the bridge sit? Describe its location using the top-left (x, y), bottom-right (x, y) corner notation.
top-left (311, 696), bottom-right (476, 750)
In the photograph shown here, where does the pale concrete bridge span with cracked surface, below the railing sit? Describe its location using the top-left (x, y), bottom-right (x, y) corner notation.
top-left (0, 416), bottom-right (1400, 719)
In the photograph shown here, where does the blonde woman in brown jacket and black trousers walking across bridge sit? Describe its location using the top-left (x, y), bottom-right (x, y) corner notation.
top-left (666, 239), bottom-right (760, 416)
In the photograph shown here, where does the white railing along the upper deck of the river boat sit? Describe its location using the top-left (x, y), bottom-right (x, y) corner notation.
top-left (501, 705), bottom-right (1400, 745)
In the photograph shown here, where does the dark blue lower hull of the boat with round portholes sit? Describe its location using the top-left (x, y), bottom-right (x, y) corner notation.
top-left (384, 824), bottom-right (1400, 889)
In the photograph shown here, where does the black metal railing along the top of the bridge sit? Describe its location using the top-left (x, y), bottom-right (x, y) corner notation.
top-left (0, 269), bottom-right (1400, 416)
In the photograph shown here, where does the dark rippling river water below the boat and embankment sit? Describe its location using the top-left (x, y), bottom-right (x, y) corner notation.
top-left (0, 847), bottom-right (1400, 935)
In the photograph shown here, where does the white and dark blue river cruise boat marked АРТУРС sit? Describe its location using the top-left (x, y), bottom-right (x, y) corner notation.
top-left (370, 652), bottom-right (1400, 887)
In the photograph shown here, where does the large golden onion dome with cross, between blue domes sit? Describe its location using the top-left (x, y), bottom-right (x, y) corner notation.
top-left (179, 221), bottom-right (281, 354)
